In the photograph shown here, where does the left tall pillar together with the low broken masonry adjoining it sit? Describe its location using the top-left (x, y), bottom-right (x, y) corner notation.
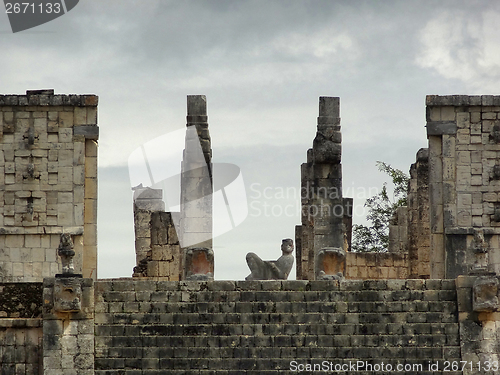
top-left (133, 95), bottom-right (214, 281)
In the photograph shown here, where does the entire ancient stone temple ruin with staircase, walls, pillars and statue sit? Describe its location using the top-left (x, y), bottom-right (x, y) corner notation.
top-left (0, 90), bottom-right (500, 375)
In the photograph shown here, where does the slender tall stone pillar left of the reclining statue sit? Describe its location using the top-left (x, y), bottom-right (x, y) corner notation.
top-left (178, 95), bottom-right (214, 280)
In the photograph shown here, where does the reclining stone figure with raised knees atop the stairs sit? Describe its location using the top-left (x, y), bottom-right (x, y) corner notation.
top-left (245, 238), bottom-right (293, 280)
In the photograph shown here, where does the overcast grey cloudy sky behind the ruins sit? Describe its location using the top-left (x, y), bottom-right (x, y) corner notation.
top-left (0, 0), bottom-right (500, 279)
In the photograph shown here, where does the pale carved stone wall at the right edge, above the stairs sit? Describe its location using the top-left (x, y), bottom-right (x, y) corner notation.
top-left (427, 95), bottom-right (500, 278)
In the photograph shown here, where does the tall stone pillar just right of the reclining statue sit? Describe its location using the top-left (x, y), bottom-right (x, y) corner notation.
top-left (296, 97), bottom-right (347, 280)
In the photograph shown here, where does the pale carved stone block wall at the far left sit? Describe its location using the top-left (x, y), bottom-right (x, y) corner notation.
top-left (0, 90), bottom-right (98, 282)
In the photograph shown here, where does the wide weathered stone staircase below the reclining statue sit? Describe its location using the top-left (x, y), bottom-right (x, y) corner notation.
top-left (95, 279), bottom-right (461, 375)
